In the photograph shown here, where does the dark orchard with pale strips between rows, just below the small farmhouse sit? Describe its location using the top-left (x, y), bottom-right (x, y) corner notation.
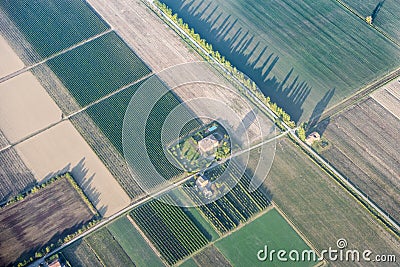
top-left (189, 162), bottom-right (270, 235)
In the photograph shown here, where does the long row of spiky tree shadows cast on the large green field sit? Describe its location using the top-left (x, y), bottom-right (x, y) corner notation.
top-left (162, 0), bottom-right (311, 122)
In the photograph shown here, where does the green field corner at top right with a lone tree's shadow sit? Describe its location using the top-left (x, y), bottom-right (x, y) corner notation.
top-left (341, 0), bottom-right (400, 43)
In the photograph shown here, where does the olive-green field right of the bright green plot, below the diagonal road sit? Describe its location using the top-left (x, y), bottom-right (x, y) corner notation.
top-left (264, 138), bottom-right (400, 266)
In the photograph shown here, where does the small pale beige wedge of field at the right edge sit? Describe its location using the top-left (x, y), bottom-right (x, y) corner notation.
top-left (371, 78), bottom-right (400, 120)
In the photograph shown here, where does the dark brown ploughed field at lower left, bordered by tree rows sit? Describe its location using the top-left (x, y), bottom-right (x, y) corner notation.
top-left (0, 177), bottom-right (94, 266)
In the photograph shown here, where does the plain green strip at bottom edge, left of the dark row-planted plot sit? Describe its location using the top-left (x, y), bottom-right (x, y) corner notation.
top-left (107, 217), bottom-right (164, 267)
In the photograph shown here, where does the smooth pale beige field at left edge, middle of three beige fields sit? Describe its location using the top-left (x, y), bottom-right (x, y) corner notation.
top-left (0, 72), bottom-right (62, 143)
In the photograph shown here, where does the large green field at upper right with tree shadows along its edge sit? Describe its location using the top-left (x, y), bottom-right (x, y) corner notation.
top-left (162, 0), bottom-right (400, 121)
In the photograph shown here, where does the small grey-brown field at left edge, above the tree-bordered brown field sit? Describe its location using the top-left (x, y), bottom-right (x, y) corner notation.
top-left (0, 148), bottom-right (36, 203)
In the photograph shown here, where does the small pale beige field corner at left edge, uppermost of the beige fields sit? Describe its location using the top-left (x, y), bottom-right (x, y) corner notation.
top-left (0, 35), bottom-right (24, 77)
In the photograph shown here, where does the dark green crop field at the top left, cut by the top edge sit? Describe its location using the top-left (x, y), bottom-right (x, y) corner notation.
top-left (0, 0), bottom-right (109, 58)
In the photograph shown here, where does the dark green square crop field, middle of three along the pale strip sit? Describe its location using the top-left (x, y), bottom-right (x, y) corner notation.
top-left (47, 32), bottom-right (150, 106)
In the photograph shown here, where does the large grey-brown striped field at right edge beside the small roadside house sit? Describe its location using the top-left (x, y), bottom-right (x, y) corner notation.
top-left (321, 96), bottom-right (400, 224)
